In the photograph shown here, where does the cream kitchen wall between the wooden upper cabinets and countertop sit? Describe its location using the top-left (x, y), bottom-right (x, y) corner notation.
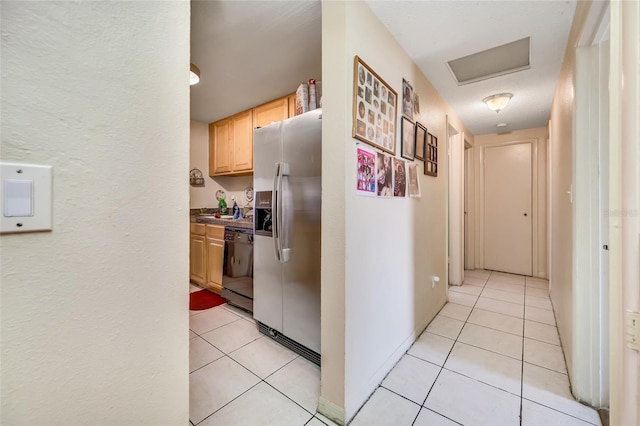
top-left (189, 120), bottom-right (253, 209)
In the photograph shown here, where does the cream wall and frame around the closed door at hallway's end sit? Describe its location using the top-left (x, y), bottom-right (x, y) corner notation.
top-left (471, 127), bottom-right (547, 278)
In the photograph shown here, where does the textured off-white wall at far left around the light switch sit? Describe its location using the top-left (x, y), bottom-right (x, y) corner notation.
top-left (0, 1), bottom-right (189, 425)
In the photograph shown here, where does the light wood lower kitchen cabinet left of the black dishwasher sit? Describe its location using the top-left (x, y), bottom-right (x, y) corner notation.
top-left (189, 223), bottom-right (224, 294)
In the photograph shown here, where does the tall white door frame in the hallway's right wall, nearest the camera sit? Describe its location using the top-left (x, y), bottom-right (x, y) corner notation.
top-left (570, 2), bottom-right (610, 407)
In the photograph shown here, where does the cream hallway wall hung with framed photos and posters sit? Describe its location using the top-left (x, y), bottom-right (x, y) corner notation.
top-left (320, 1), bottom-right (473, 421)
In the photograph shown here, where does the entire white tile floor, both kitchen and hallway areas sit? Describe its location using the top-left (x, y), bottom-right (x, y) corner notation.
top-left (190, 271), bottom-right (601, 426)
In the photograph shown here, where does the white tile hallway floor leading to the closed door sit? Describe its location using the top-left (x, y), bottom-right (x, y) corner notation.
top-left (351, 271), bottom-right (600, 426)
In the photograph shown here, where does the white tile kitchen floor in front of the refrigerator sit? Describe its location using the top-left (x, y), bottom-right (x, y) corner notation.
top-left (189, 285), bottom-right (334, 426)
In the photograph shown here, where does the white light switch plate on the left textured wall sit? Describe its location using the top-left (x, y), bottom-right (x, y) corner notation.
top-left (0, 162), bottom-right (53, 234)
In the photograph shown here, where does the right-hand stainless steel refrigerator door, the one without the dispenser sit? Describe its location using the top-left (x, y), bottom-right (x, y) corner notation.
top-left (281, 110), bottom-right (322, 352)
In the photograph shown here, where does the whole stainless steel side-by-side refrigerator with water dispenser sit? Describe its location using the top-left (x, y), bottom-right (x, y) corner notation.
top-left (253, 109), bottom-right (322, 364)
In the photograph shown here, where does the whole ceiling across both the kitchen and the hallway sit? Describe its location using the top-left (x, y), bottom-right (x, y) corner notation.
top-left (191, 0), bottom-right (576, 135)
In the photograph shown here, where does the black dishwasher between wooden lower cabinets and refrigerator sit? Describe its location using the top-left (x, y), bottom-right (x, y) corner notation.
top-left (222, 227), bottom-right (253, 313)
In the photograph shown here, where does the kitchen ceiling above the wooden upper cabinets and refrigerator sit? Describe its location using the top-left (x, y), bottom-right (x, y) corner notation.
top-left (191, 0), bottom-right (322, 123)
